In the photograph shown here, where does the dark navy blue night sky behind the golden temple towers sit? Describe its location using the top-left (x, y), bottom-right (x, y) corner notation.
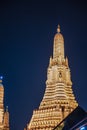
top-left (0, 0), bottom-right (87, 130)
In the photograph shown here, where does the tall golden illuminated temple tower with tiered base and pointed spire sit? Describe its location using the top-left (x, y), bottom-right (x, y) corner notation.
top-left (27, 25), bottom-right (78, 130)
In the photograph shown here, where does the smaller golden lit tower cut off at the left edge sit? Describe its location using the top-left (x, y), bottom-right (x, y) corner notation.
top-left (0, 79), bottom-right (10, 130)
